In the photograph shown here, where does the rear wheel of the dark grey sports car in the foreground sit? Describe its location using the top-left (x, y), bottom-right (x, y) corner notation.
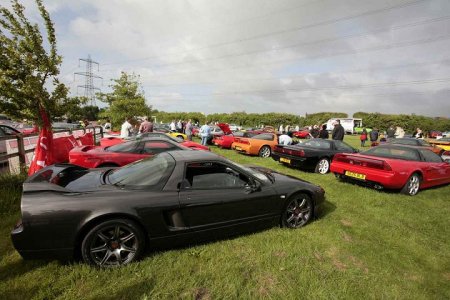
top-left (81, 219), bottom-right (145, 267)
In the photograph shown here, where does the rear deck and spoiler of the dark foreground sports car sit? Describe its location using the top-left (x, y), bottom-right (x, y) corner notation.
top-left (23, 164), bottom-right (116, 193)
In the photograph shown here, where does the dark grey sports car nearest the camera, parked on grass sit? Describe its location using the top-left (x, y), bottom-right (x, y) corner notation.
top-left (11, 151), bottom-right (325, 266)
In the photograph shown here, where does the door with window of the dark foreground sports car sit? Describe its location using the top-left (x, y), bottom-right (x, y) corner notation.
top-left (179, 162), bottom-right (278, 230)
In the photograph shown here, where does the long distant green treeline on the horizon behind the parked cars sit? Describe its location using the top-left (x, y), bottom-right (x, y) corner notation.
top-left (152, 111), bottom-right (450, 132)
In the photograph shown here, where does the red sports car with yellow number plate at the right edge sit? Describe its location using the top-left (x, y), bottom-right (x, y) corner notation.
top-left (330, 145), bottom-right (450, 196)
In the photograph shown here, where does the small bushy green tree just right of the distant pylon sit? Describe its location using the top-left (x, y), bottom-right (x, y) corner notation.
top-left (97, 72), bottom-right (152, 126)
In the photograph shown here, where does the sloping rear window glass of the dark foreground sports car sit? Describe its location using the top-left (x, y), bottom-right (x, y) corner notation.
top-left (108, 153), bottom-right (175, 188)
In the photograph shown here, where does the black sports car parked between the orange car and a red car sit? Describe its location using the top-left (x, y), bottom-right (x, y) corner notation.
top-left (272, 139), bottom-right (358, 174)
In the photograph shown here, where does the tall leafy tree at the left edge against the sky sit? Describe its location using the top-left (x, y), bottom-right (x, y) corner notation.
top-left (0, 0), bottom-right (68, 125)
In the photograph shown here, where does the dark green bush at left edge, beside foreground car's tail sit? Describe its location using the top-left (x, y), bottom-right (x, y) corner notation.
top-left (0, 174), bottom-right (26, 216)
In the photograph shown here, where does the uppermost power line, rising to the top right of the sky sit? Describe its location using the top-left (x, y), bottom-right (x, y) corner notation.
top-left (104, 0), bottom-right (429, 65)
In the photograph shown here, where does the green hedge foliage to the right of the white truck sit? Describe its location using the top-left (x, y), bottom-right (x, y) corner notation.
top-left (353, 112), bottom-right (450, 132)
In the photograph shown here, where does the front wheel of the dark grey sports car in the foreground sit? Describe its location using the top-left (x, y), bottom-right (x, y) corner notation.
top-left (281, 193), bottom-right (314, 228)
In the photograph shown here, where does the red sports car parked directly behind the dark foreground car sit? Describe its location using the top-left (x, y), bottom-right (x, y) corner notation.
top-left (69, 138), bottom-right (191, 168)
